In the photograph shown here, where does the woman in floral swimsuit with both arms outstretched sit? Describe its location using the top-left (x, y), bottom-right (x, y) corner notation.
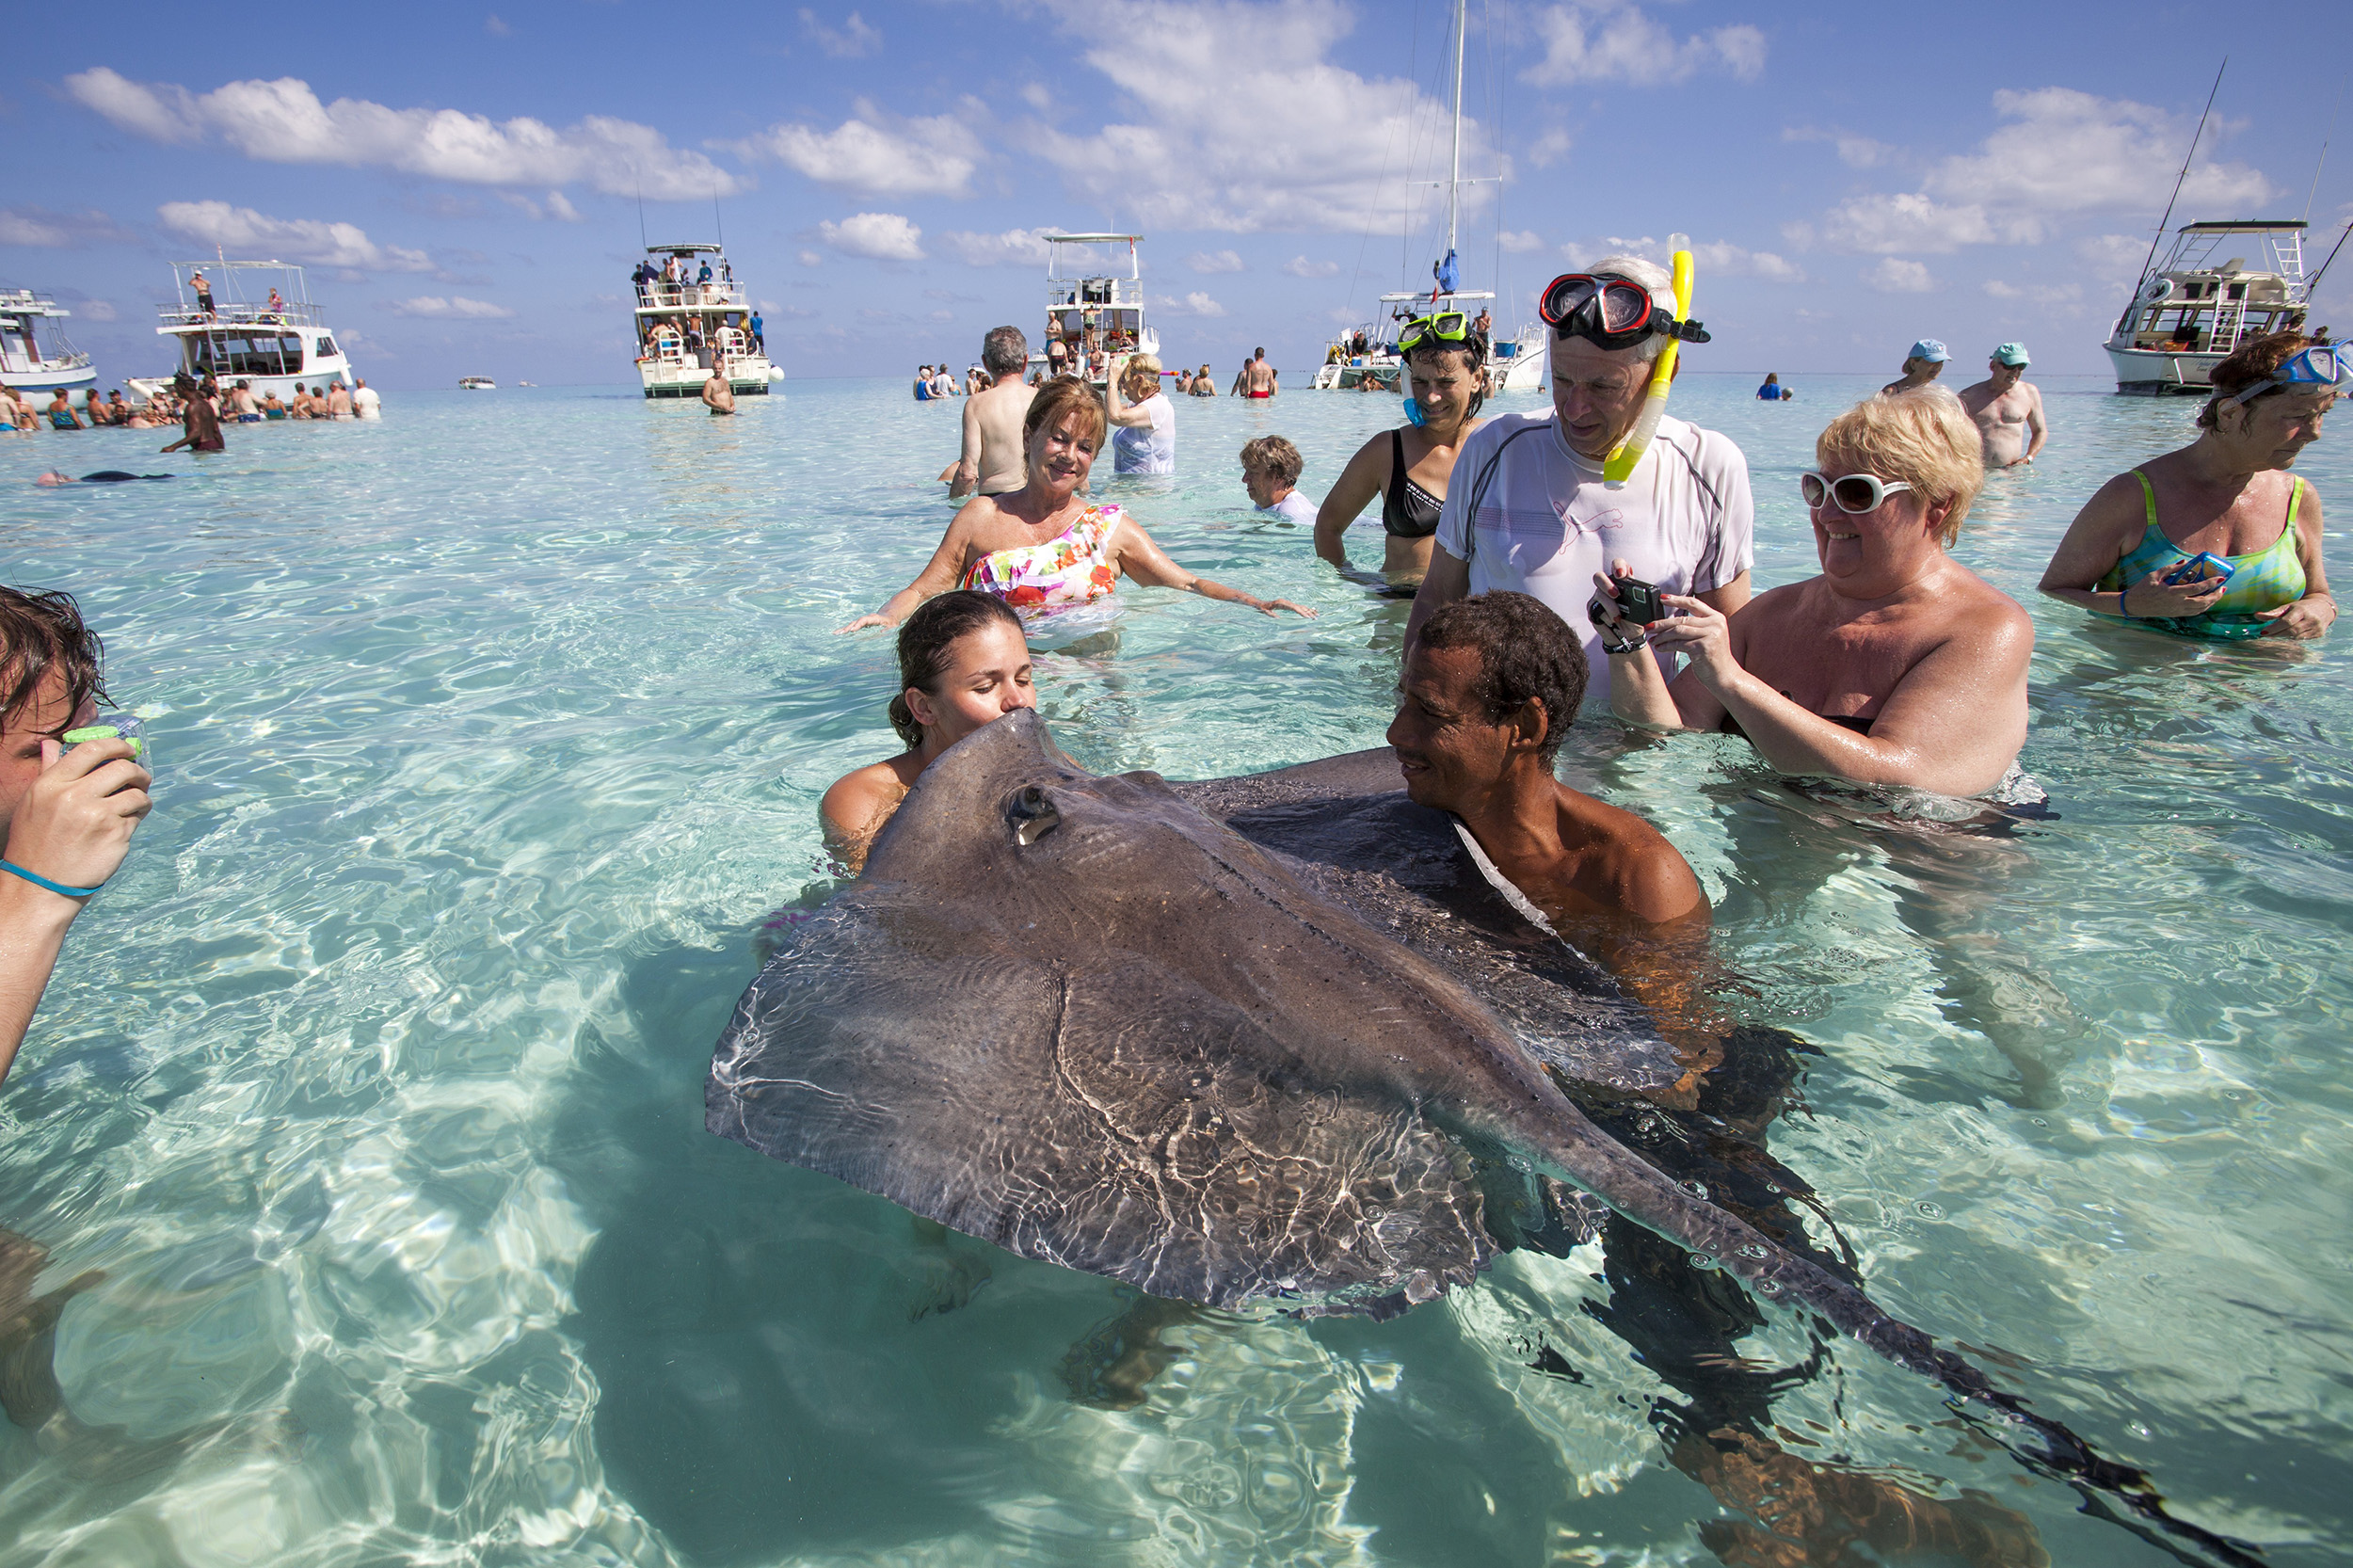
top-left (842, 376), bottom-right (1316, 631)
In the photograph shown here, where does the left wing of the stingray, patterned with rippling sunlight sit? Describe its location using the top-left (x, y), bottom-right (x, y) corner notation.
top-left (706, 888), bottom-right (1495, 1311)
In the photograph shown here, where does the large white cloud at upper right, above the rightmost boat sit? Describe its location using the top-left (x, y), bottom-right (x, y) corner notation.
top-left (1784, 88), bottom-right (2273, 254)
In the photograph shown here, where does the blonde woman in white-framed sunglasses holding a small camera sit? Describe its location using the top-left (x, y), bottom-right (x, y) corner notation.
top-left (1591, 389), bottom-right (2036, 796)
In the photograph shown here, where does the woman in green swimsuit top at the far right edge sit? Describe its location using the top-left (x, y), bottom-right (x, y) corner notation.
top-left (2041, 332), bottom-right (2353, 640)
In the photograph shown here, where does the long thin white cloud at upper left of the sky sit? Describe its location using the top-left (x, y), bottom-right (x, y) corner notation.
top-left (66, 66), bottom-right (744, 200)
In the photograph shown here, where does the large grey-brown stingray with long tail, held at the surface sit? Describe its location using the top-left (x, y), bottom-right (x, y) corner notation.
top-left (706, 711), bottom-right (2245, 1560)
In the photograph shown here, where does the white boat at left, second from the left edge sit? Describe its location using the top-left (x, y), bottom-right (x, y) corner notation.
top-left (125, 262), bottom-right (358, 398)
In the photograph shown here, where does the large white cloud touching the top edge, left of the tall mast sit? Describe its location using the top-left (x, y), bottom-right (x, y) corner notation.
top-left (1016, 0), bottom-right (1509, 235)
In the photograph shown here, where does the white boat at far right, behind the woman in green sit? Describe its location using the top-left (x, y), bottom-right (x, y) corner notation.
top-left (2106, 221), bottom-right (2311, 398)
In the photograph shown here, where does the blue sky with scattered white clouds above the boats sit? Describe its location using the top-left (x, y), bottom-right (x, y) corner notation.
top-left (0, 0), bottom-right (2353, 389)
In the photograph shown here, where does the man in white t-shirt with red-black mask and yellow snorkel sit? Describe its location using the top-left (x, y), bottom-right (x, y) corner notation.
top-left (1405, 257), bottom-right (1755, 704)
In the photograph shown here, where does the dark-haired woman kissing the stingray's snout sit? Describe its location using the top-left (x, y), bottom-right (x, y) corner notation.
top-left (817, 588), bottom-right (1038, 876)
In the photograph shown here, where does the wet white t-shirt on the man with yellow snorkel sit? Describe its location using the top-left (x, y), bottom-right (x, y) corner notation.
top-left (1438, 412), bottom-right (1755, 704)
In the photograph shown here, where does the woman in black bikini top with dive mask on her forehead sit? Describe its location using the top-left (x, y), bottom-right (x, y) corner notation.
top-left (1316, 311), bottom-right (1487, 588)
